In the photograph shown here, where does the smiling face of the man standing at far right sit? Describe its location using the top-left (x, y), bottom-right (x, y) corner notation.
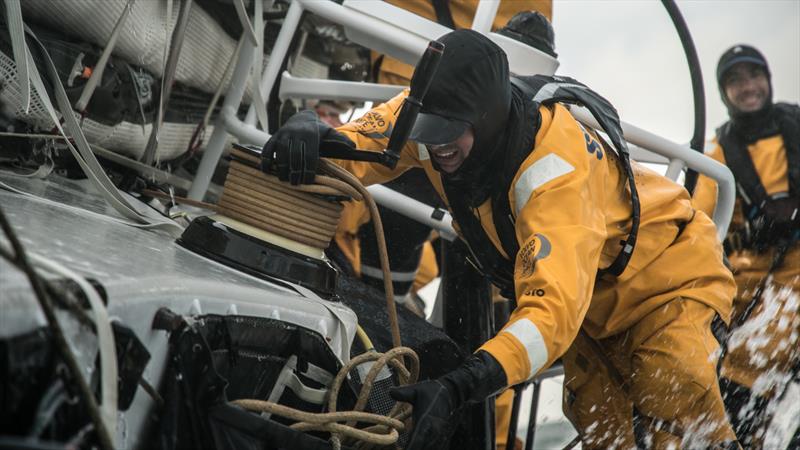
top-left (724, 63), bottom-right (769, 113)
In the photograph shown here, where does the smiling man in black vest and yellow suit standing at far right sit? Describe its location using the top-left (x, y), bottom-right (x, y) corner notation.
top-left (694, 45), bottom-right (800, 447)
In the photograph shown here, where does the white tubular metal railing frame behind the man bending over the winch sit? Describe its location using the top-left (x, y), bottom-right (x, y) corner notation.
top-left (189, 0), bottom-right (735, 237)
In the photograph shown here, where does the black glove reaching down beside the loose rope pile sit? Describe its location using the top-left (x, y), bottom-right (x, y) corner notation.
top-left (389, 350), bottom-right (507, 450)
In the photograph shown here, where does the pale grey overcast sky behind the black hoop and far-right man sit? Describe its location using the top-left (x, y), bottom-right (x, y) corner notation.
top-left (553, 0), bottom-right (800, 143)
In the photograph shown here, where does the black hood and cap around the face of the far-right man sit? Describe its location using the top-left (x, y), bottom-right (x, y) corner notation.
top-left (717, 44), bottom-right (772, 129)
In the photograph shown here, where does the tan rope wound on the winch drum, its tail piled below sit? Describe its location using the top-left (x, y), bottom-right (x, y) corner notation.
top-left (217, 149), bottom-right (412, 449)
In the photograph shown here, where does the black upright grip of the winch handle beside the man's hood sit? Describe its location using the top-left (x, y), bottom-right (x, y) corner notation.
top-left (383, 41), bottom-right (444, 169)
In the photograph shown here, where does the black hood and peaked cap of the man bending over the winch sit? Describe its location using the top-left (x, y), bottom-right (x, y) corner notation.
top-left (422, 30), bottom-right (511, 205)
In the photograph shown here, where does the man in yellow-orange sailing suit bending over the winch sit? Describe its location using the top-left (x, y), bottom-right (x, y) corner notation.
top-left (263, 30), bottom-right (738, 449)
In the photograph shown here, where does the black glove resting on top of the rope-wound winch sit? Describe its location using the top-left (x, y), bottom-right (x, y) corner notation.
top-left (261, 111), bottom-right (355, 184)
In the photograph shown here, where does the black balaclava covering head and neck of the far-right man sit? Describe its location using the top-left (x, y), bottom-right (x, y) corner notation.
top-left (717, 44), bottom-right (777, 142)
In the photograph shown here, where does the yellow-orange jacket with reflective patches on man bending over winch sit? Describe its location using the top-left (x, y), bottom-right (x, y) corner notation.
top-left (337, 91), bottom-right (735, 385)
